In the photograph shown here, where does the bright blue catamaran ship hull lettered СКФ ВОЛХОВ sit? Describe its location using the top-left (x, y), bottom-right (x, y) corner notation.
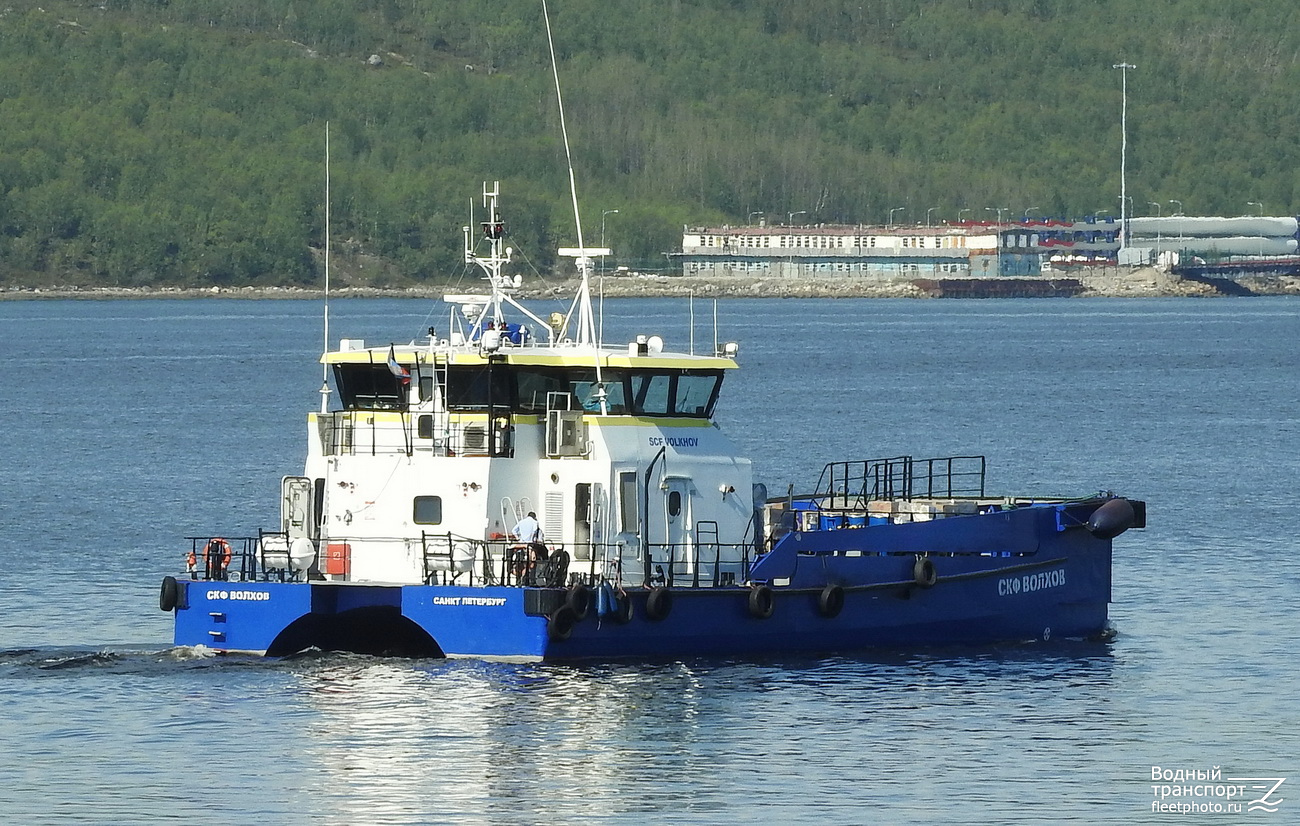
top-left (176, 501), bottom-right (1128, 661)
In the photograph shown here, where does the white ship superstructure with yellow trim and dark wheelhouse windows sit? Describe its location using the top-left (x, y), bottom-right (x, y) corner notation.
top-left (282, 186), bottom-right (757, 584)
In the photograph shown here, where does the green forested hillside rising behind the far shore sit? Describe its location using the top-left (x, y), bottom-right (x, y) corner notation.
top-left (0, 0), bottom-right (1300, 285)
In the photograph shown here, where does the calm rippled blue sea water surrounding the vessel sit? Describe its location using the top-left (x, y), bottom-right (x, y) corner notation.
top-left (0, 299), bottom-right (1300, 826)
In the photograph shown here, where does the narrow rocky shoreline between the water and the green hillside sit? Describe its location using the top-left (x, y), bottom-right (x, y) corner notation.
top-left (0, 267), bottom-right (1300, 300)
